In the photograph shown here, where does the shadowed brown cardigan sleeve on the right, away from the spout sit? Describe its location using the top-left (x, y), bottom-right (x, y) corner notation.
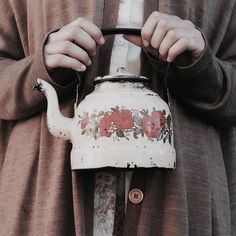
top-left (150, 8), bottom-right (236, 126)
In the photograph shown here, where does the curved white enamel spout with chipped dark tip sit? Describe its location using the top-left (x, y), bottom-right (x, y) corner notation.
top-left (33, 78), bottom-right (73, 140)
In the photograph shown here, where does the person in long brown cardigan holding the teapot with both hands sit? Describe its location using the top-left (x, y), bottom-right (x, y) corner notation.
top-left (0, 0), bottom-right (236, 236)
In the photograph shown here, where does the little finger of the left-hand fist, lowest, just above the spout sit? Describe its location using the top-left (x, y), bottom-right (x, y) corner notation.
top-left (45, 54), bottom-right (86, 71)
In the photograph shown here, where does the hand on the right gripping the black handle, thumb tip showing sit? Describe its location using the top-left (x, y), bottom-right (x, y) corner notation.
top-left (125, 11), bottom-right (205, 62)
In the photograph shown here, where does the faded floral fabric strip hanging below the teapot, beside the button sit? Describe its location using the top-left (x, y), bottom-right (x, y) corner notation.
top-left (93, 171), bottom-right (128, 236)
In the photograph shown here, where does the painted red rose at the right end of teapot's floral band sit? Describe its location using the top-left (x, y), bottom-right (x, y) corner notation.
top-left (142, 110), bottom-right (166, 138)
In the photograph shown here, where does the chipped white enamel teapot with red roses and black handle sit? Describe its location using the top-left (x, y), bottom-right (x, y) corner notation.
top-left (34, 29), bottom-right (176, 170)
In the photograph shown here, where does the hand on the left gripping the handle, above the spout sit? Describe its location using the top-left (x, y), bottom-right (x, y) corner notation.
top-left (44, 17), bottom-right (105, 71)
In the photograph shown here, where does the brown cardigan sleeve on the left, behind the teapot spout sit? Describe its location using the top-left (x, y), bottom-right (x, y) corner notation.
top-left (0, 0), bottom-right (75, 120)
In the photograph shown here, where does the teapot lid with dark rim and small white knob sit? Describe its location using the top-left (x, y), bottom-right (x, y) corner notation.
top-left (94, 68), bottom-right (149, 85)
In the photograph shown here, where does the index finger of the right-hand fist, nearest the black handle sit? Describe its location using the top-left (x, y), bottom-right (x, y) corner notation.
top-left (141, 11), bottom-right (160, 47)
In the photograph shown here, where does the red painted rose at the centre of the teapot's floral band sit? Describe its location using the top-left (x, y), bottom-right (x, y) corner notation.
top-left (111, 109), bottom-right (134, 131)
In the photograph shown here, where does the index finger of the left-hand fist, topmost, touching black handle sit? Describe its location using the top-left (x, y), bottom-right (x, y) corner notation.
top-left (71, 17), bottom-right (105, 45)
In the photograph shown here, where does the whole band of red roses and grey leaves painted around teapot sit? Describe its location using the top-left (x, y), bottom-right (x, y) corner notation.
top-left (80, 106), bottom-right (172, 143)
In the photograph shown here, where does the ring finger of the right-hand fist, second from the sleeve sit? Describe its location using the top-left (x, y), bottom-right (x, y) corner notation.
top-left (159, 29), bottom-right (183, 58)
